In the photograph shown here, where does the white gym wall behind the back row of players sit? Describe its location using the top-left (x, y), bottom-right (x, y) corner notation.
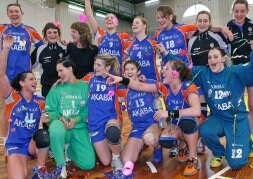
top-left (0, 0), bottom-right (253, 39)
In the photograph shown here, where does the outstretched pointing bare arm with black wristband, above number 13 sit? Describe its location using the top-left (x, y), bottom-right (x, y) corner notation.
top-left (107, 74), bottom-right (158, 93)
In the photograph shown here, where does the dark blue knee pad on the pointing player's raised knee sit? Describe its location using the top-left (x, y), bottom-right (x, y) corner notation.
top-left (178, 117), bottom-right (198, 134)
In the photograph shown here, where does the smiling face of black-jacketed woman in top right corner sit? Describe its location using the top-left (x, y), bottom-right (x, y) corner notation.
top-left (232, 4), bottom-right (249, 25)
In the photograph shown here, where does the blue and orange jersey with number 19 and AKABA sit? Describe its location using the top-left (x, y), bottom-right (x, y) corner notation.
top-left (82, 73), bottom-right (121, 127)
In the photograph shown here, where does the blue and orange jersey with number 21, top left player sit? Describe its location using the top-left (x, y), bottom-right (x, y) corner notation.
top-left (0, 24), bottom-right (43, 81)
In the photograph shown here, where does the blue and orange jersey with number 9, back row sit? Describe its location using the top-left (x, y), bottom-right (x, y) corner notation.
top-left (96, 27), bottom-right (130, 70)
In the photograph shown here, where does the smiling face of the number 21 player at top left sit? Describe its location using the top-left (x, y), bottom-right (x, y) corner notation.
top-left (7, 5), bottom-right (23, 26)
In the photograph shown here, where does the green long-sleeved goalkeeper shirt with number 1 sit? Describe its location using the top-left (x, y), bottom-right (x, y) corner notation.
top-left (45, 81), bottom-right (89, 128)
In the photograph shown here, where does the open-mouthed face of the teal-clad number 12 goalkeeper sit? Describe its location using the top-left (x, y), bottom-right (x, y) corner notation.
top-left (208, 49), bottom-right (225, 73)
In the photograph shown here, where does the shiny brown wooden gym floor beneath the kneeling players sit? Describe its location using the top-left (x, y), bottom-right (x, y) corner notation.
top-left (0, 112), bottom-right (253, 179)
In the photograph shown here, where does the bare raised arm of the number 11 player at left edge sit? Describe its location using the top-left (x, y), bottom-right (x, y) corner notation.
top-left (0, 35), bottom-right (14, 98)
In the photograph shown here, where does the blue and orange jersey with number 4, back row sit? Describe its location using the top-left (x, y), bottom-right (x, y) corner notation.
top-left (124, 36), bottom-right (160, 81)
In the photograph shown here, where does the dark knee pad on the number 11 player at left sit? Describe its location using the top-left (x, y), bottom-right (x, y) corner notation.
top-left (33, 129), bottom-right (50, 149)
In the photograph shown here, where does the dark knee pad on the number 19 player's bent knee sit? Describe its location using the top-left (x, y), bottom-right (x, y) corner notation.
top-left (105, 124), bottom-right (121, 145)
